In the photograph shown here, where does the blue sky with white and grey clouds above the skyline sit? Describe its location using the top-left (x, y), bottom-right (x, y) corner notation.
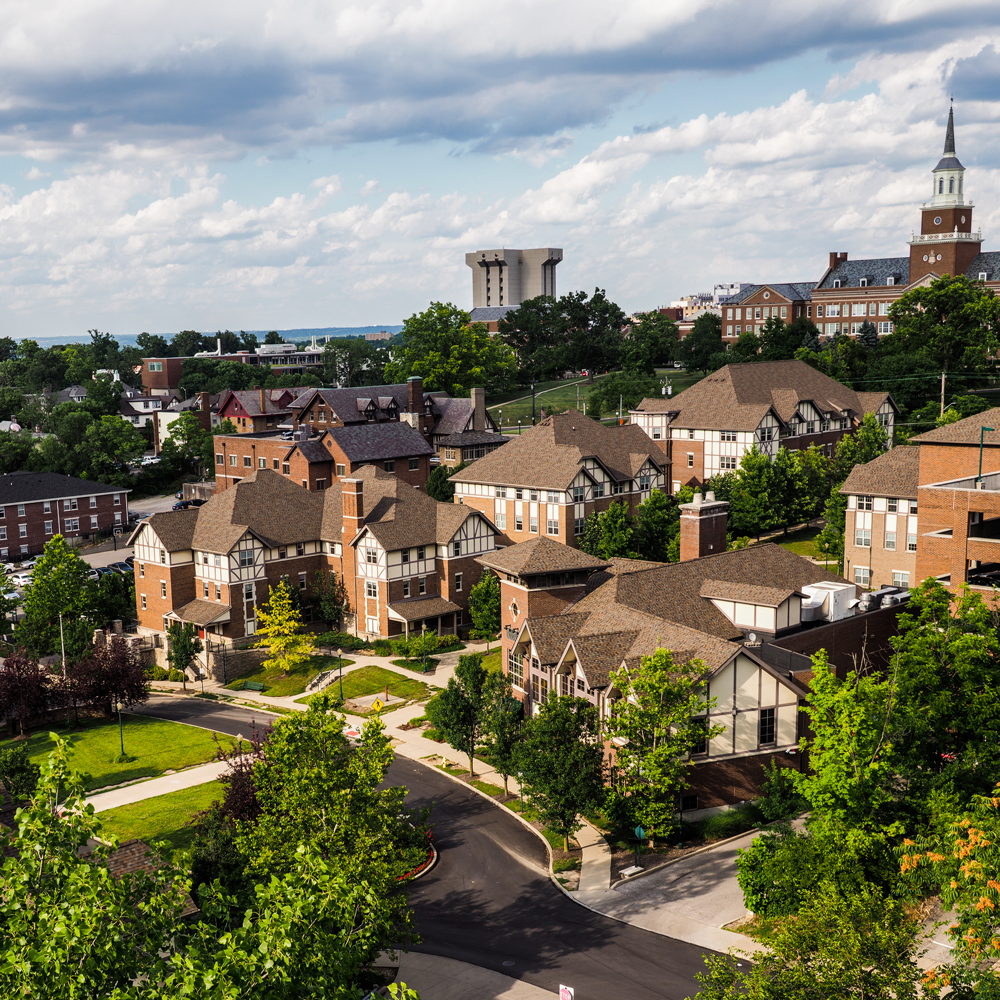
top-left (0, 0), bottom-right (1000, 337)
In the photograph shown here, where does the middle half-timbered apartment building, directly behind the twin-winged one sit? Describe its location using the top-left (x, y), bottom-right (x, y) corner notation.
top-left (450, 411), bottom-right (669, 546)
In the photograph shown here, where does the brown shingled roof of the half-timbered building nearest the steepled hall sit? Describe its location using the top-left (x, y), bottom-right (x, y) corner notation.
top-left (636, 360), bottom-right (890, 431)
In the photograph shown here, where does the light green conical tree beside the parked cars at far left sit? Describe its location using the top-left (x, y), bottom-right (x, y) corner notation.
top-left (14, 535), bottom-right (92, 660)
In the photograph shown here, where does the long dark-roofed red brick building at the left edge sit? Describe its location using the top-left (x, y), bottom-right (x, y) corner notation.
top-left (0, 472), bottom-right (130, 562)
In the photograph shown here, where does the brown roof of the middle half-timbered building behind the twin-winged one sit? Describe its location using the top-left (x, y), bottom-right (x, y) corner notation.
top-left (451, 411), bottom-right (665, 490)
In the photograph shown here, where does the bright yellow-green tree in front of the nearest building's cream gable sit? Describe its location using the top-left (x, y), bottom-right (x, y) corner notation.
top-left (605, 649), bottom-right (725, 842)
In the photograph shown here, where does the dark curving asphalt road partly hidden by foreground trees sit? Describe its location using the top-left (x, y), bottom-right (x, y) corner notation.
top-left (139, 696), bottom-right (705, 1000)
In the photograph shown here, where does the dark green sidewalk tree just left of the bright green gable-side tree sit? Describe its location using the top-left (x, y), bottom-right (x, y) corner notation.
top-left (518, 697), bottom-right (604, 851)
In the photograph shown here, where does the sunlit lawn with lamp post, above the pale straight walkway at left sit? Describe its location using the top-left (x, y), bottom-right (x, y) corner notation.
top-left (14, 714), bottom-right (216, 791)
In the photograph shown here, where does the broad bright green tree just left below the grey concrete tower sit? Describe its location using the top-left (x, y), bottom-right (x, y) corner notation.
top-left (385, 302), bottom-right (517, 396)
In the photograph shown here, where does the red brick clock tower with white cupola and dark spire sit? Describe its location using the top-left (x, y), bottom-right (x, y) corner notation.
top-left (910, 106), bottom-right (983, 284)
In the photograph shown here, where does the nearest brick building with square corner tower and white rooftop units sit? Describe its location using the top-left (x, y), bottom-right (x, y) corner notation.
top-left (488, 504), bottom-right (880, 811)
